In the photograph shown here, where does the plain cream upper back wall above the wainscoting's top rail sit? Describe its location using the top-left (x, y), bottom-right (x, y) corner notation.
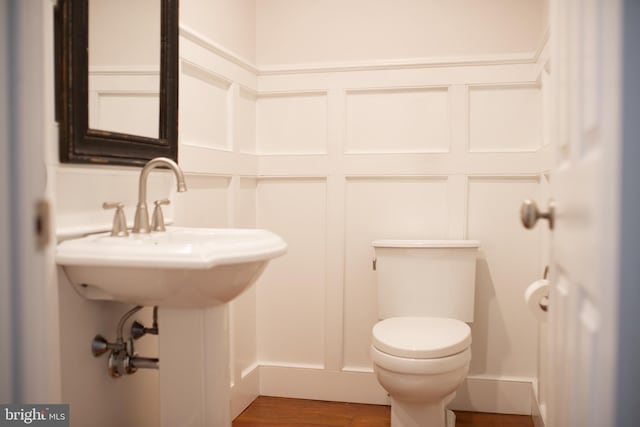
top-left (256, 0), bottom-right (546, 66)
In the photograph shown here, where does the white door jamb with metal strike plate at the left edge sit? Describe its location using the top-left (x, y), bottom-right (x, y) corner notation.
top-left (0, 0), bottom-right (60, 403)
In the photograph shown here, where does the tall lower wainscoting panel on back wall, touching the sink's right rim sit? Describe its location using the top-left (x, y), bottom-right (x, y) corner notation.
top-left (256, 177), bottom-right (326, 368)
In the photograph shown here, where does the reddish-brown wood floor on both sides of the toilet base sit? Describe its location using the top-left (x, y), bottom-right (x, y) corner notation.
top-left (233, 396), bottom-right (533, 427)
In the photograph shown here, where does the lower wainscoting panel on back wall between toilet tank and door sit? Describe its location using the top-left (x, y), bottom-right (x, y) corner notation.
top-left (467, 176), bottom-right (543, 377)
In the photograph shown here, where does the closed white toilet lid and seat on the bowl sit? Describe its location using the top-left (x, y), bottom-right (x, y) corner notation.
top-left (373, 317), bottom-right (471, 359)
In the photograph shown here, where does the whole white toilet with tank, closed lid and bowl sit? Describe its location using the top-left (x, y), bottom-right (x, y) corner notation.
top-left (371, 240), bottom-right (480, 427)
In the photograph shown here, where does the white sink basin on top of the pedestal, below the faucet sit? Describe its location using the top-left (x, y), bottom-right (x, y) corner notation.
top-left (56, 227), bottom-right (287, 308)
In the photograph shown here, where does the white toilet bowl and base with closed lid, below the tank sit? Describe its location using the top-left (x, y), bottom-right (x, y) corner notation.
top-left (371, 317), bottom-right (471, 427)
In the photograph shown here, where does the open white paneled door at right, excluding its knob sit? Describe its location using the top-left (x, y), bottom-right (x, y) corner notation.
top-left (547, 0), bottom-right (621, 427)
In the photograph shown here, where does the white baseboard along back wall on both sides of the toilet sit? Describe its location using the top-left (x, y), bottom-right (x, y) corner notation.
top-left (245, 365), bottom-right (544, 416)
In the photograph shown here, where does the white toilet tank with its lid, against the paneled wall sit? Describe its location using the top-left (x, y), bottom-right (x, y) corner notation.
top-left (372, 240), bottom-right (480, 322)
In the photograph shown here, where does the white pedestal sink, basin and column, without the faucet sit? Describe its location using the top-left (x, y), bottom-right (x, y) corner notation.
top-left (56, 227), bottom-right (287, 427)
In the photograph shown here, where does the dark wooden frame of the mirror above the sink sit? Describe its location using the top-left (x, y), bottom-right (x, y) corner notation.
top-left (54, 0), bottom-right (179, 166)
